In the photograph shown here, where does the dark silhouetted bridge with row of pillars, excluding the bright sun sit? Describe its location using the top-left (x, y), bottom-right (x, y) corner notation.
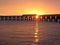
top-left (0, 15), bottom-right (60, 22)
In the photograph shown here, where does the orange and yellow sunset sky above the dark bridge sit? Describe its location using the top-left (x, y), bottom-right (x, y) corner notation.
top-left (0, 0), bottom-right (60, 15)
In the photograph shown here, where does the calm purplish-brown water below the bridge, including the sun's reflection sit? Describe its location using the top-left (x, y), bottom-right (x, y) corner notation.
top-left (0, 21), bottom-right (60, 45)
